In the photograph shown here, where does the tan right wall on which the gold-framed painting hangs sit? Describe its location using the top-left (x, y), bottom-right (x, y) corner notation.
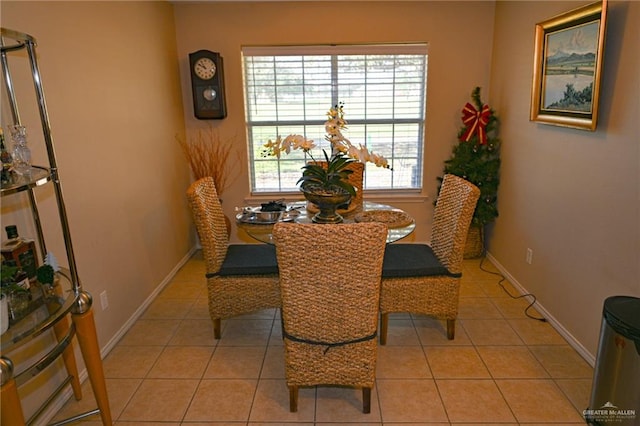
top-left (489, 1), bottom-right (640, 361)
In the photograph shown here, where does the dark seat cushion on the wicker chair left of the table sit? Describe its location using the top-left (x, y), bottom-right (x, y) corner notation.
top-left (207, 244), bottom-right (278, 277)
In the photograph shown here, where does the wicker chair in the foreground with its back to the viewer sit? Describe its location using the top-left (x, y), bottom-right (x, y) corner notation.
top-left (273, 223), bottom-right (387, 413)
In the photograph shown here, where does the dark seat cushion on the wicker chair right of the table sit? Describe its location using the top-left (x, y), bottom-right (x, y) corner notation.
top-left (382, 244), bottom-right (460, 278)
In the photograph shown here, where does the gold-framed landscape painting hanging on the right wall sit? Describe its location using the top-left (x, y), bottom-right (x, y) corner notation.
top-left (530, 0), bottom-right (607, 131)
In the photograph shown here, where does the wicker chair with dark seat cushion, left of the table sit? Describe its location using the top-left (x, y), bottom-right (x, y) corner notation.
top-left (187, 177), bottom-right (280, 339)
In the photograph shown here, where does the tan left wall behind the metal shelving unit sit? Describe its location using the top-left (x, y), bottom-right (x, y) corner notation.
top-left (0, 1), bottom-right (194, 416)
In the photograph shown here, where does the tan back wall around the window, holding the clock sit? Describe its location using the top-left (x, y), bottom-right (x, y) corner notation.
top-left (174, 1), bottom-right (494, 241)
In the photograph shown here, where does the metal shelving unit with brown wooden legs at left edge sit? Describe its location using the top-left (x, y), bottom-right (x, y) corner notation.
top-left (0, 28), bottom-right (112, 426)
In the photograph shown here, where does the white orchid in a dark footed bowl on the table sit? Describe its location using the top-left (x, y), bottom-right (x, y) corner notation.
top-left (264, 103), bottom-right (390, 223)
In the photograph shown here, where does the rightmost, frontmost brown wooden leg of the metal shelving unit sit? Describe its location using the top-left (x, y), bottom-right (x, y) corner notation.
top-left (71, 302), bottom-right (112, 426)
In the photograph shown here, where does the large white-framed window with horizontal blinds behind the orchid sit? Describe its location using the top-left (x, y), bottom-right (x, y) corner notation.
top-left (242, 44), bottom-right (427, 193)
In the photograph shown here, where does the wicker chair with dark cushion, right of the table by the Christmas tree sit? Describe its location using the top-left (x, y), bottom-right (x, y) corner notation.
top-left (380, 174), bottom-right (480, 345)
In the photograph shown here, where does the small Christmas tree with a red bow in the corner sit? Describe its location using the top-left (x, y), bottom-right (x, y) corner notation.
top-left (440, 87), bottom-right (500, 257)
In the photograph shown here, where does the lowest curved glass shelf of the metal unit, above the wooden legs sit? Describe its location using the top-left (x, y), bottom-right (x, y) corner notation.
top-left (0, 269), bottom-right (76, 354)
